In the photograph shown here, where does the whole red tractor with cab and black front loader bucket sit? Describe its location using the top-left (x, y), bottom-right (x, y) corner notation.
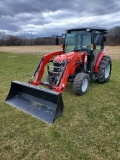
top-left (5, 28), bottom-right (112, 124)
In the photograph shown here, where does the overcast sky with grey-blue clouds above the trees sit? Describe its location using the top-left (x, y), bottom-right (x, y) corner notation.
top-left (0, 0), bottom-right (120, 36)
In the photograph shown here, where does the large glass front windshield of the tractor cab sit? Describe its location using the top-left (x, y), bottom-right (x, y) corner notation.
top-left (65, 31), bottom-right (91, 52)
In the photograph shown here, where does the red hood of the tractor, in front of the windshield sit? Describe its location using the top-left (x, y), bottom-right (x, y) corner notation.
top-left (54, 52), bottom-right (78, 62)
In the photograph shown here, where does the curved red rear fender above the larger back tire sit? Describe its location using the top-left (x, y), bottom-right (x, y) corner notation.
top-left (94, 51), bottom-right (107, 73)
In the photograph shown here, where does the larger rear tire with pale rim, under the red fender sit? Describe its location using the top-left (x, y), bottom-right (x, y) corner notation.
top-left (96, 56), bottom-right (112, 83)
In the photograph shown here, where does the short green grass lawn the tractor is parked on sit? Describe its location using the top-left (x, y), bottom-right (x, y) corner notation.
top-left (0, 53), bottom-right (120, 160)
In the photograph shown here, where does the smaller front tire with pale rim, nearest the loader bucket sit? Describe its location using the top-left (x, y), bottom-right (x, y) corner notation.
top-left (73, 73), bottom-right (90, 96)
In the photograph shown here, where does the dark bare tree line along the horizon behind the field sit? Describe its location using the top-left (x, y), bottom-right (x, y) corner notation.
top-left (0, 26), bottom-right (120, 46)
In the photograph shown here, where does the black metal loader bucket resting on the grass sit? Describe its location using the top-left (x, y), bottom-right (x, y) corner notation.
top-left (5, 81), bottom-right (63, 124)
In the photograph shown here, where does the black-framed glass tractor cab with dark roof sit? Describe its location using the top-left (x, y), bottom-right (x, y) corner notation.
top-left (63, 27), bottom-right (108, 73)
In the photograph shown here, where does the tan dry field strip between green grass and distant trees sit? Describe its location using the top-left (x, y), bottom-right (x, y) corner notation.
top-left (0, 46), bottom-right (120, 59)
